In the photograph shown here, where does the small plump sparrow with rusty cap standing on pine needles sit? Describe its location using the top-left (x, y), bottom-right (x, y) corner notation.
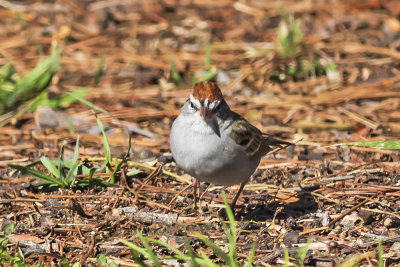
top-left (170, 82), bottom-right (291, 208)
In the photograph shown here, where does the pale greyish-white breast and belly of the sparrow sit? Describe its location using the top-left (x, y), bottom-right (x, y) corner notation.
top-left (170, 114), bottom-right (259, 186)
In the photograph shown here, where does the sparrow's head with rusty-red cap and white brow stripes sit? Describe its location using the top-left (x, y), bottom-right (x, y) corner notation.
top-left (189, 82), bottom-right (224, 121)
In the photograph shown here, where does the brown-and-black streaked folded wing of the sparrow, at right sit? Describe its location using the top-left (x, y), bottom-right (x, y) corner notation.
top-left (230, 114), bottom-right (292, 157)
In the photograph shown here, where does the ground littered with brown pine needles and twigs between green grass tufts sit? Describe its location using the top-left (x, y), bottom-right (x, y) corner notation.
top-left (0, 0), bottom-right (400, 266)
